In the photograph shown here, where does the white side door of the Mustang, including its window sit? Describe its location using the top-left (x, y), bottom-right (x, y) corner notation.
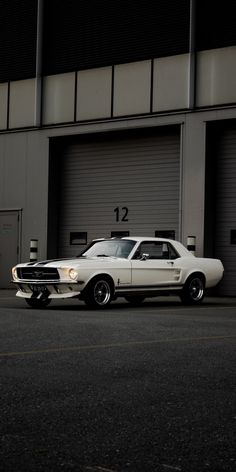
top-left (131, 241), bottom-right (179, 288)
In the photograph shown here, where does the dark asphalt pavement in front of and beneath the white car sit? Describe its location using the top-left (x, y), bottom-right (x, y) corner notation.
top-left (0, 290), bottom-right (236, 472)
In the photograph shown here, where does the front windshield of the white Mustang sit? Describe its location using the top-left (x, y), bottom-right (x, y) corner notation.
top-left (80, 239), bottom-right (136, 259)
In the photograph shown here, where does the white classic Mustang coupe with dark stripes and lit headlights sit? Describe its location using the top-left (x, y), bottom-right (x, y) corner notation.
top-left (12, 237), bottom-right (224, 308)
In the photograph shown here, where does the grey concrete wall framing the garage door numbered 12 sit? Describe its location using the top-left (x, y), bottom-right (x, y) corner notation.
top-left (0, 114), bottom-right (205, 260)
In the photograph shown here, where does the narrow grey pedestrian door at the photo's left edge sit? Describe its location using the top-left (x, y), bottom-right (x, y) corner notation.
top-left (0, 210), bottom-right (20, 288)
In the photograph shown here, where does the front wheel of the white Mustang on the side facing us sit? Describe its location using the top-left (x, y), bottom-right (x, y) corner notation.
top-left (83, 276), bottom-right (114, 308)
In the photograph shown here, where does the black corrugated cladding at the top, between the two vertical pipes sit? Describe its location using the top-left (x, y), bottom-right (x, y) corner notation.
top-left (44, 0), bottom-right (190, 75)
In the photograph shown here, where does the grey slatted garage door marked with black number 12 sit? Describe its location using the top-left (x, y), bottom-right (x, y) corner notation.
top-left (59, 129), bottom-right (180, 257)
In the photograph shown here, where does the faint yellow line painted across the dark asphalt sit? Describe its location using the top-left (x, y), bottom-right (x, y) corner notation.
top-left (0, 335), bottom-right (236, 358)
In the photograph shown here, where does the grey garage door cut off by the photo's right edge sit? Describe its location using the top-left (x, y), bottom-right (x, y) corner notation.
top-left (215, 126), bottom-right (236, 296)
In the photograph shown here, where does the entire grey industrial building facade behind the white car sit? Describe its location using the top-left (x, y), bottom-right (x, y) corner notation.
top-left (0, 0), bottom-right (236, 295)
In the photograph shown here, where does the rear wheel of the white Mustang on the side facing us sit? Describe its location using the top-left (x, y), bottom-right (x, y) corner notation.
top-left (180, 274), bottom-right (205, 305)
